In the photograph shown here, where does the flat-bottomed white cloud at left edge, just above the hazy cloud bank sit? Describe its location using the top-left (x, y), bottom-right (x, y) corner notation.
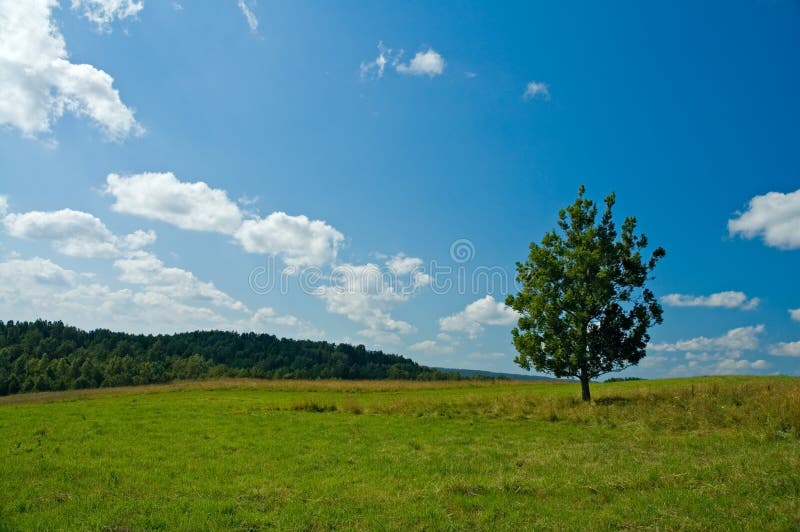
top-left (3, 209), bottom-right (156, 258)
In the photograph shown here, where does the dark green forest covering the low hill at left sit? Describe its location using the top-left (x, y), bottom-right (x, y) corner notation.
top-left (0, 320), bottom-right (460, 395)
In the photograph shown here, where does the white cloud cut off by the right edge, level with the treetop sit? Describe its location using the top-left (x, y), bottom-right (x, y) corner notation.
top-left (728, 190), bottom-right (800, 249)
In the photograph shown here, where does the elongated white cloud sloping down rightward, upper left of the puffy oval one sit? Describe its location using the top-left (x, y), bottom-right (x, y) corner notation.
top-left (105, 172), bottom-right (242, 234)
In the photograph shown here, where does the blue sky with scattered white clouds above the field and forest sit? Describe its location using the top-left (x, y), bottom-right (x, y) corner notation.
top-left (0, 0), bottom-right (800, 377)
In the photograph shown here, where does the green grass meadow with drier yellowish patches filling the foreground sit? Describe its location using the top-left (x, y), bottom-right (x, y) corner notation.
top-left (0, 377), bottom-right (800, 530)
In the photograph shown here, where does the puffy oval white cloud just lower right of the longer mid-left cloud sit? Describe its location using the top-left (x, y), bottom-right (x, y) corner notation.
top-left (234, 212), bottom-right (344, 266)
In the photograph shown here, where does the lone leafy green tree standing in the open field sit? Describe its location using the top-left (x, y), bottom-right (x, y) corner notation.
top-left (506, 186), bottom-right (666, 401)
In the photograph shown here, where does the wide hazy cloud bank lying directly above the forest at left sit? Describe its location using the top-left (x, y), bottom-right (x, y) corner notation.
top-left (0, 253), bottom-right (325, 338)
